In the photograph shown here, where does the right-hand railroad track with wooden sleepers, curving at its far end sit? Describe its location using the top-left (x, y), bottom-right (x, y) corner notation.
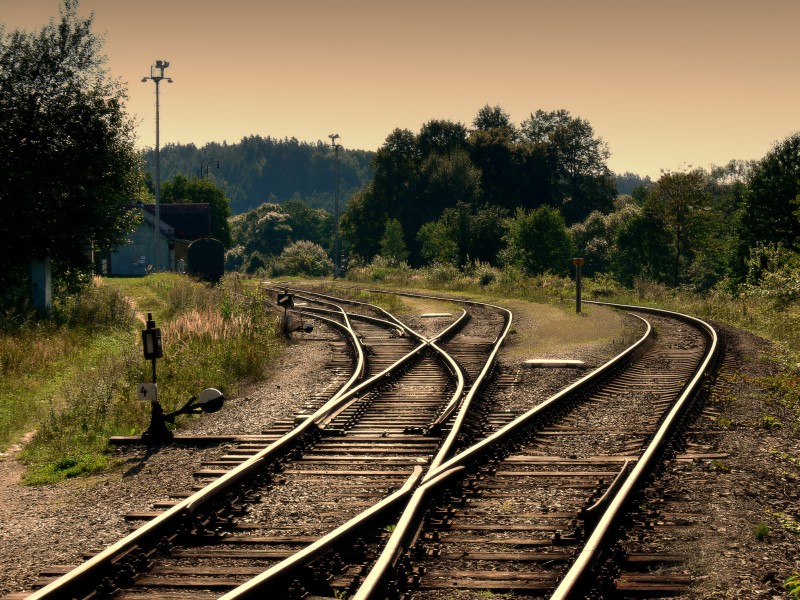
top-left (348, 304), bottom-right (716, 599)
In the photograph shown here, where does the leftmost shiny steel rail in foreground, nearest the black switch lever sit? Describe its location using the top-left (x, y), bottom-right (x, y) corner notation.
top-left (21, 292), bottom-right (406, 600)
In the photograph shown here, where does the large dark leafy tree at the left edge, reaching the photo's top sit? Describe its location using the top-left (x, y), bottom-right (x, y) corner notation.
top-left (0, 0), bottom-right (143, 298)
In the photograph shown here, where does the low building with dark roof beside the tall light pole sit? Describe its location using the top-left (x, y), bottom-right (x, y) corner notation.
top-left (95, 203), bottom-right (211, 277)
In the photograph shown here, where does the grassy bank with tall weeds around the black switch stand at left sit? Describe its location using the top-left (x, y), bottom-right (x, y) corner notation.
top-left (0, 274), bottom-right (280, 484)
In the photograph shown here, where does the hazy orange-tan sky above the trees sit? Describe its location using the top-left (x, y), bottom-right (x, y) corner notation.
top-left (0, 0), bottom-right (800, 178)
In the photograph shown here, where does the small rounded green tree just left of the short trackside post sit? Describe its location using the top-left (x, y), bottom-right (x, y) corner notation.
top-left (505, 206), bottom-right (574, 275)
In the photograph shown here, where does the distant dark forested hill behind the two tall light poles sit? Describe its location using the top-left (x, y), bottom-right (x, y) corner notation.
top-left (143, 136), bottom-right (374, 214)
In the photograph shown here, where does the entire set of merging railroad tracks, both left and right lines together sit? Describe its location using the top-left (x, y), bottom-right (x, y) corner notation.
top-left (7, 292), bottom-right (714, 600)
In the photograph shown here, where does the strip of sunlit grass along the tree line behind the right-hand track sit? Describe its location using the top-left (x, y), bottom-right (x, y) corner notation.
top-left (347, 263), bottom-right (800, 436)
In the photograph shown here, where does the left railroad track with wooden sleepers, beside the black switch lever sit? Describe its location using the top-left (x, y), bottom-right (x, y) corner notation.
top-left (6, 284), bottom-right (510, 598)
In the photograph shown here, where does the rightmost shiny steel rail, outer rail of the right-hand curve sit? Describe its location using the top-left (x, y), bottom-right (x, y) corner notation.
top-left (551, 302), bottom-right (719, 600)
